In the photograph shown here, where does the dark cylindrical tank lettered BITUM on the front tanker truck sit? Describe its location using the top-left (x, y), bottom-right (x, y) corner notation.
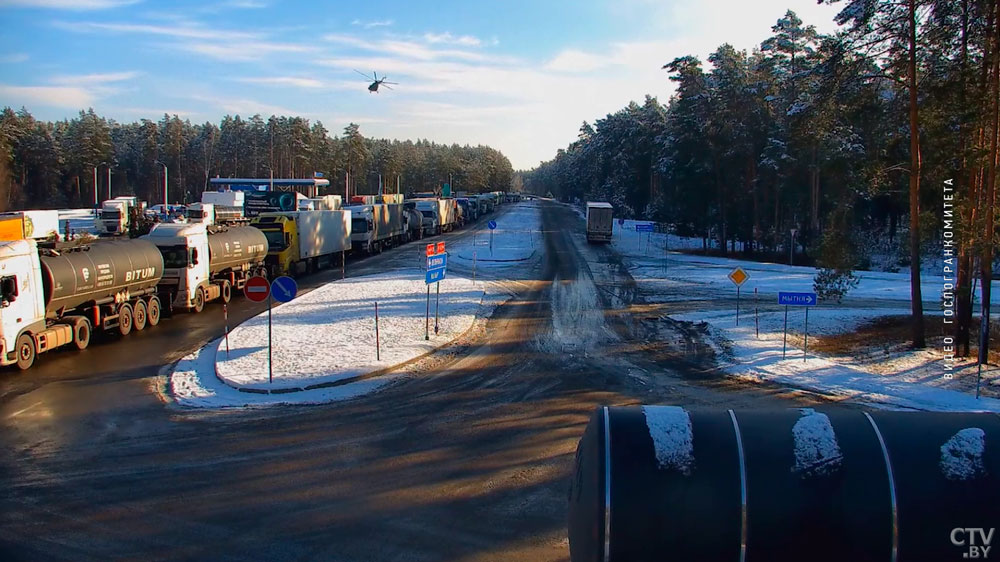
top-left (41, 240), bottom-right (163, 314)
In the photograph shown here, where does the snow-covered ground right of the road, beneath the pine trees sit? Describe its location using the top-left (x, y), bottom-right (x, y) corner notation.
top-left (584, 210), bottom-right (1000, 411)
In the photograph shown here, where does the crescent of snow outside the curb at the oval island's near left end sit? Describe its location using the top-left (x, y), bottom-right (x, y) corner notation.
top-left (167, 339), bottom-right (400, 408)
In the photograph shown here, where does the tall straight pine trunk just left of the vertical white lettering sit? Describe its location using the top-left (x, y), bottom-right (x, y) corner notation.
top-left (907, 0), bottom-right (926, 349)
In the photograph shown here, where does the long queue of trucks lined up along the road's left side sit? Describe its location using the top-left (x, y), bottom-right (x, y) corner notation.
top-left (0, 185), bottom-right (504, 369)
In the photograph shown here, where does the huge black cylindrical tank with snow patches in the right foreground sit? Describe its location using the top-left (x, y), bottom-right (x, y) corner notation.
top-left (569, 406), bottom-right (1000, 562)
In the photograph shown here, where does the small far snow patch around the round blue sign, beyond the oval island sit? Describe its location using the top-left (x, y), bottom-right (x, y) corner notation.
top-left (448, 201), bottom-right (543, 272)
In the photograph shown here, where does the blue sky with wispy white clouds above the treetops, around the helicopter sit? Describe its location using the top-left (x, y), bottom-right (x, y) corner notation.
top-left (0, 0), bottom-right (839, 169)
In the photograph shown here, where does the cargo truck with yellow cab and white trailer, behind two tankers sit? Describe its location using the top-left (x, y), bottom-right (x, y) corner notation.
top-left (250, 210), bottom-right (351, 277)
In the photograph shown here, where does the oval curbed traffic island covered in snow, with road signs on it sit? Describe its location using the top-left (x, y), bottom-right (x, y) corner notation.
top-left (216, 270), bottom-right (495, 391)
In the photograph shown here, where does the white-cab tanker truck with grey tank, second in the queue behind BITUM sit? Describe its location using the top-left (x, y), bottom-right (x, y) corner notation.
top-left (144, 223), bottom-right (267, 312)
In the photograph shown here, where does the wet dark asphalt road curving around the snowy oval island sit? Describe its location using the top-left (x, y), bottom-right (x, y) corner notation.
top-left (0, 203), bottom-right (824, 561)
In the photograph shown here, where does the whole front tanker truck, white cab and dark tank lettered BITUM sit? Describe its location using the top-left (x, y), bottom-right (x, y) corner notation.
top-left (0, 239), bottom-right (163, 369)
